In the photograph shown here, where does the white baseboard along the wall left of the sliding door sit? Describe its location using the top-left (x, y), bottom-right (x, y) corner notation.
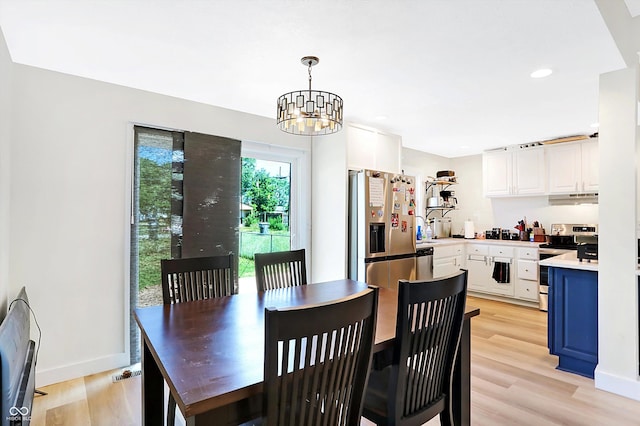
top-left (36, 353), bottom-right (130, 387)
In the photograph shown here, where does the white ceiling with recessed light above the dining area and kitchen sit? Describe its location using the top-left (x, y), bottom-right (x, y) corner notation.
top-left (0, 0), bottom-right (640, 157)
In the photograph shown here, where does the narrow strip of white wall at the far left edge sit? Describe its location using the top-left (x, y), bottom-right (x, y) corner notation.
top-left (0, 30), bottom-right (11, 314)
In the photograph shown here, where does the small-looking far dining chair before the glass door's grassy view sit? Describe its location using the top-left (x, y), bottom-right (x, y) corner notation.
top-left (254, 249), bottom-right (307, 291)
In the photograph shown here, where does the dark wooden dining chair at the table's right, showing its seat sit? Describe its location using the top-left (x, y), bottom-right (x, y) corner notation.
top-left (362, 270), bottom-right (467, 425)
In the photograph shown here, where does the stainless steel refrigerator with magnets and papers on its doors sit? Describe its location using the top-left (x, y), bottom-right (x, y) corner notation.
top-left (348, 170), bottom-right (417, 288)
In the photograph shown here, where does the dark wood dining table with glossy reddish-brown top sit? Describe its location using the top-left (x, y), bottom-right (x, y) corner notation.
top-left (134, 279), bottom-right (480, 425)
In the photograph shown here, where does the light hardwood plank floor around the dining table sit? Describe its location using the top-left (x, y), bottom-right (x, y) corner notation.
top-left (31, 297), bottom-right (640, 426)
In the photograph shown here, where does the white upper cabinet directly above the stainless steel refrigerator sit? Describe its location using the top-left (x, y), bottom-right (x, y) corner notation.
top-left (346, 125), bottom-right (402, 173)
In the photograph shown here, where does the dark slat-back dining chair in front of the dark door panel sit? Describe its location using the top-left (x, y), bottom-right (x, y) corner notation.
top-left (160, 254), bottom-right (235, 426)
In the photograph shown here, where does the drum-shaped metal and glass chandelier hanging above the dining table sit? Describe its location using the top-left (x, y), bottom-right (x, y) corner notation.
top-left (276, 56), bottom-right (342, 136)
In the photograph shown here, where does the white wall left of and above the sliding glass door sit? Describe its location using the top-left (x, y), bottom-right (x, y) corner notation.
top-left (9, 59), bottom-right (310, 386)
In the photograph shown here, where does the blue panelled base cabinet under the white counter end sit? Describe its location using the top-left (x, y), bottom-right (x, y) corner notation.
top-left (548, 267), bottom-right (598, 378)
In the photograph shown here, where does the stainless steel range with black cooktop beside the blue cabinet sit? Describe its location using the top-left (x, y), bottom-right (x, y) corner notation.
top-left (538, 223), bottom-right (598, 311)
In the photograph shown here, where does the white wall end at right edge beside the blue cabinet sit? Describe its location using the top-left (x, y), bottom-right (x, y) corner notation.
top-left (595, 62), bottom-right (640, 400)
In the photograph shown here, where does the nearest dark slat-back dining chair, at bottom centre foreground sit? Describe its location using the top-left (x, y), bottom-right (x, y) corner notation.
top-left (261, 288), bottom-right (378, 426)
